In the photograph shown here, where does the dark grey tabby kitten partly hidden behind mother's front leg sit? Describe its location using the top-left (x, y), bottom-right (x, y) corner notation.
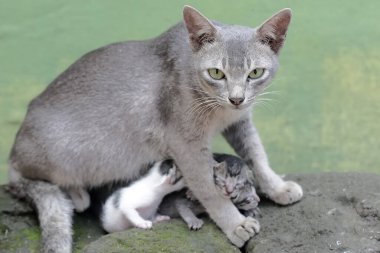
top-left (159, 154), bottom-right (260, 230)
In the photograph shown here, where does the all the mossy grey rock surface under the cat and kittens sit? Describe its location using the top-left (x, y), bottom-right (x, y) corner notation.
top-left (0, 173), bottom-right (380, 253)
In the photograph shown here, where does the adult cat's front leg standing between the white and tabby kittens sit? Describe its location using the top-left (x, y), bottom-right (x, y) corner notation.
top-left (171, 141), bottom-right (260, 247)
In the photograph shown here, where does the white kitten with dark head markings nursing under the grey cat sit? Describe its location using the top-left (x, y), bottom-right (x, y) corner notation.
top-left (101, 160), bottom-right (185, 233)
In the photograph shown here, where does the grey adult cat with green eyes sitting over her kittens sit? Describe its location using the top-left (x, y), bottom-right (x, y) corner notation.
top-left (9, 6), bottom-right (302, 252)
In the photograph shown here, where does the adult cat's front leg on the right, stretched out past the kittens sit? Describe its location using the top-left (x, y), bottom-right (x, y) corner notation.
top-left (223, 115), bottom-right (303, 205)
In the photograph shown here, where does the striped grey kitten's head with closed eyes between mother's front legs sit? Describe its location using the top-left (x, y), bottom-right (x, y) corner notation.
top-left (213, 161), bottom-right (247, 198)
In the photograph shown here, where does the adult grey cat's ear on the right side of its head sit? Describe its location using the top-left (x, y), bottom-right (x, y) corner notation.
top-left (256, 9), bottom-right (292, 54)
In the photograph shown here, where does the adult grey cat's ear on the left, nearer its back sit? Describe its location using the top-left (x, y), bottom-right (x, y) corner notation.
top-left (183, 5), bottom-right (216, 52)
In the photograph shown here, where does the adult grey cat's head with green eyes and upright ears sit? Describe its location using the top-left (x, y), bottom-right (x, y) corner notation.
top-left (183, 6), bottom-right (291, 109)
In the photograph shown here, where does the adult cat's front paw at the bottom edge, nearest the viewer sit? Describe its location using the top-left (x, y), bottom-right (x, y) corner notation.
top-left (227, 217), bottom-right (260, 248)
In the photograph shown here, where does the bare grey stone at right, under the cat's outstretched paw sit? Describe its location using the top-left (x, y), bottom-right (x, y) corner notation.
top-left (246, 173), bottom-right (380, 253)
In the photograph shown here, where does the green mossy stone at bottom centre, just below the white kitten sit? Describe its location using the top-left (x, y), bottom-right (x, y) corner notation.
top-left (84, 219), bottom-right (240, 253)
